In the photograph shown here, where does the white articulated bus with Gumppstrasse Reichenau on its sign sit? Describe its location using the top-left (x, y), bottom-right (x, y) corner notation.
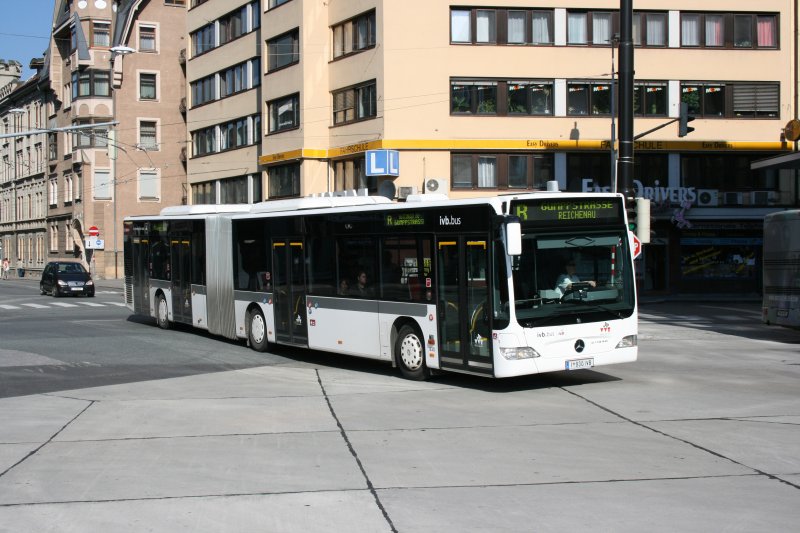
top-left (124, 192), bottom-right (637, 379)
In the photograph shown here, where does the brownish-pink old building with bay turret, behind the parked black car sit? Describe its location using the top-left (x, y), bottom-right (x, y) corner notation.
top-left (46, 0), bottom-right (188, 278)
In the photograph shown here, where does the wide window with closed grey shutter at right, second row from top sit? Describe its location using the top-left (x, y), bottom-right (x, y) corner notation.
top-left (681, 82), bottom-right (780, 118)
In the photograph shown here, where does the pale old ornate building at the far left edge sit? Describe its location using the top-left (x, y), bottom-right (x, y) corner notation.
top-left (0, 59), bottom-right (47, 275)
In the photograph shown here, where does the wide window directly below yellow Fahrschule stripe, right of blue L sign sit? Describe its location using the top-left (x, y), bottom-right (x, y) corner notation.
top-left (450, 153), bottom-right (554, 190)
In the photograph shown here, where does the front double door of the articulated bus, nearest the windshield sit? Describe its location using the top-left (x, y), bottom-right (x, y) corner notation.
top-left (437, 235), bottom-right (492, 374)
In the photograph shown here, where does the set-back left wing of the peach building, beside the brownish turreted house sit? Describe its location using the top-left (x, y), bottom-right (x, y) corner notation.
top-left (186, 0), bottom-right (265, 204)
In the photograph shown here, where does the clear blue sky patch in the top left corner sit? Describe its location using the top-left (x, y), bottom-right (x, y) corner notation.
top-left (0, 0), bottom-right (56, 80)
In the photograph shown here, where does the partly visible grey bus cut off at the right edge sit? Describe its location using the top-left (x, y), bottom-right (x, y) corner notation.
top-left (761, 209), bottom-right (800, 328)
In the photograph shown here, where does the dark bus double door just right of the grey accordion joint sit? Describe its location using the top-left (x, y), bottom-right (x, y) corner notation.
top-left (272, 237), bottom-right (308, 346)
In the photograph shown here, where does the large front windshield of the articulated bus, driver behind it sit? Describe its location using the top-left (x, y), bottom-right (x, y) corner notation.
top-left (512, 231), bottom-right (634, 327)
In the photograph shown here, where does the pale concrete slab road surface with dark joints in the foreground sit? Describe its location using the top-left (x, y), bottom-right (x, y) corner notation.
top-left (0, 276), bottom-right (800, 532)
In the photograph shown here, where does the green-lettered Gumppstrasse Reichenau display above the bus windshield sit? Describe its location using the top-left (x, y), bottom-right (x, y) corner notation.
top-left (511, 198), bottom-right (622, 223)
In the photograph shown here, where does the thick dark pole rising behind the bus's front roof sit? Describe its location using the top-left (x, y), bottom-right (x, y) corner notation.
top-left (617, 0), bottom-right (636, 202)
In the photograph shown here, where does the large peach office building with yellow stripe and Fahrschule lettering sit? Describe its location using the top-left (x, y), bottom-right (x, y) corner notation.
top-left (180, 0), bottom-right (800, 294)
